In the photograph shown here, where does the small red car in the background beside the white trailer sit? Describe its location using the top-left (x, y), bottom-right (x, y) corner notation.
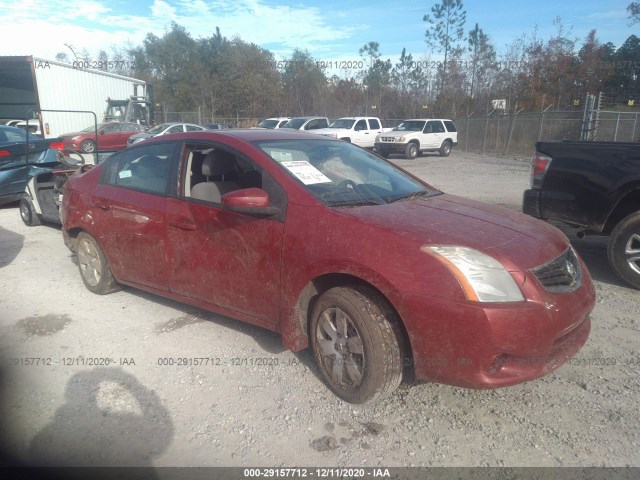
top-left (60, 122), bottom-right (144, 153)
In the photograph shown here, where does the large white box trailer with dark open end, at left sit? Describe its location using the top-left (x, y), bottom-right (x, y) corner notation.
top-left (0, 56), bottom-right (148, 138)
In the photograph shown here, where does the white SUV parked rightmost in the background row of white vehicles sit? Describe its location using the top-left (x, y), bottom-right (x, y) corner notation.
top-left (375, 118), bottom-right (458, 159)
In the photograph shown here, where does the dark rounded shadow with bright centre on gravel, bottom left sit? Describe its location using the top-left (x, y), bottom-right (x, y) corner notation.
top-left (28, 367), bottom-right (174, 468)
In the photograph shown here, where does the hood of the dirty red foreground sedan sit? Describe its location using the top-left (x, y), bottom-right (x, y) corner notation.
top-left (338, 194), bottom-right (569, 270)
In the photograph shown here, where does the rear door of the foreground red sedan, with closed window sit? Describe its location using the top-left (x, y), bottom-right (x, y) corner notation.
top-left (90, 142), bottom-right (179, 290)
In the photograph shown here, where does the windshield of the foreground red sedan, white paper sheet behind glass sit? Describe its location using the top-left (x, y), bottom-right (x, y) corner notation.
top-left (256, 140), bottom-right (440, 207)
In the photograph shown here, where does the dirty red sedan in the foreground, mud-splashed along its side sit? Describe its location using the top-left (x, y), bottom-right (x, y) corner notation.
top-left (61, 130), bottom-right (594, 403)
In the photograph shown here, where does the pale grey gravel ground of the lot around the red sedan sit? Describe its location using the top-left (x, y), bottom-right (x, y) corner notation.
top-left (0, 151), bottom-right (640, 466)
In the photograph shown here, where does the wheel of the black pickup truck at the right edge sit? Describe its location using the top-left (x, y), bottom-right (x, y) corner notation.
top-left (607, 212), bottom-right (640, 289)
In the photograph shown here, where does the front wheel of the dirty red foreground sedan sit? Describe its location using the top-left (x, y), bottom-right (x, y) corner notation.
top-left (310, 286), bottom-right (403, 404)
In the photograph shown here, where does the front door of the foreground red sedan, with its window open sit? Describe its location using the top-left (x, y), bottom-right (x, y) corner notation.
top-left (167, 144), bottom-right (286, 324)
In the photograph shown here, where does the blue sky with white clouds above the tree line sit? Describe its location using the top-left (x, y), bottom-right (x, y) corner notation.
top-left (0, 0), bottom-right (640, 67)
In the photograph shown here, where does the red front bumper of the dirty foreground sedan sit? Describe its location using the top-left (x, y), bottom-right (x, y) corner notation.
top-left (400, 265), bottom-right (595, 388)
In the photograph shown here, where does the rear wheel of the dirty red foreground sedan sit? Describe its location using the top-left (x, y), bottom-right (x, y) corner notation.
top-left (76, 232), bottom-right (120, 295)
